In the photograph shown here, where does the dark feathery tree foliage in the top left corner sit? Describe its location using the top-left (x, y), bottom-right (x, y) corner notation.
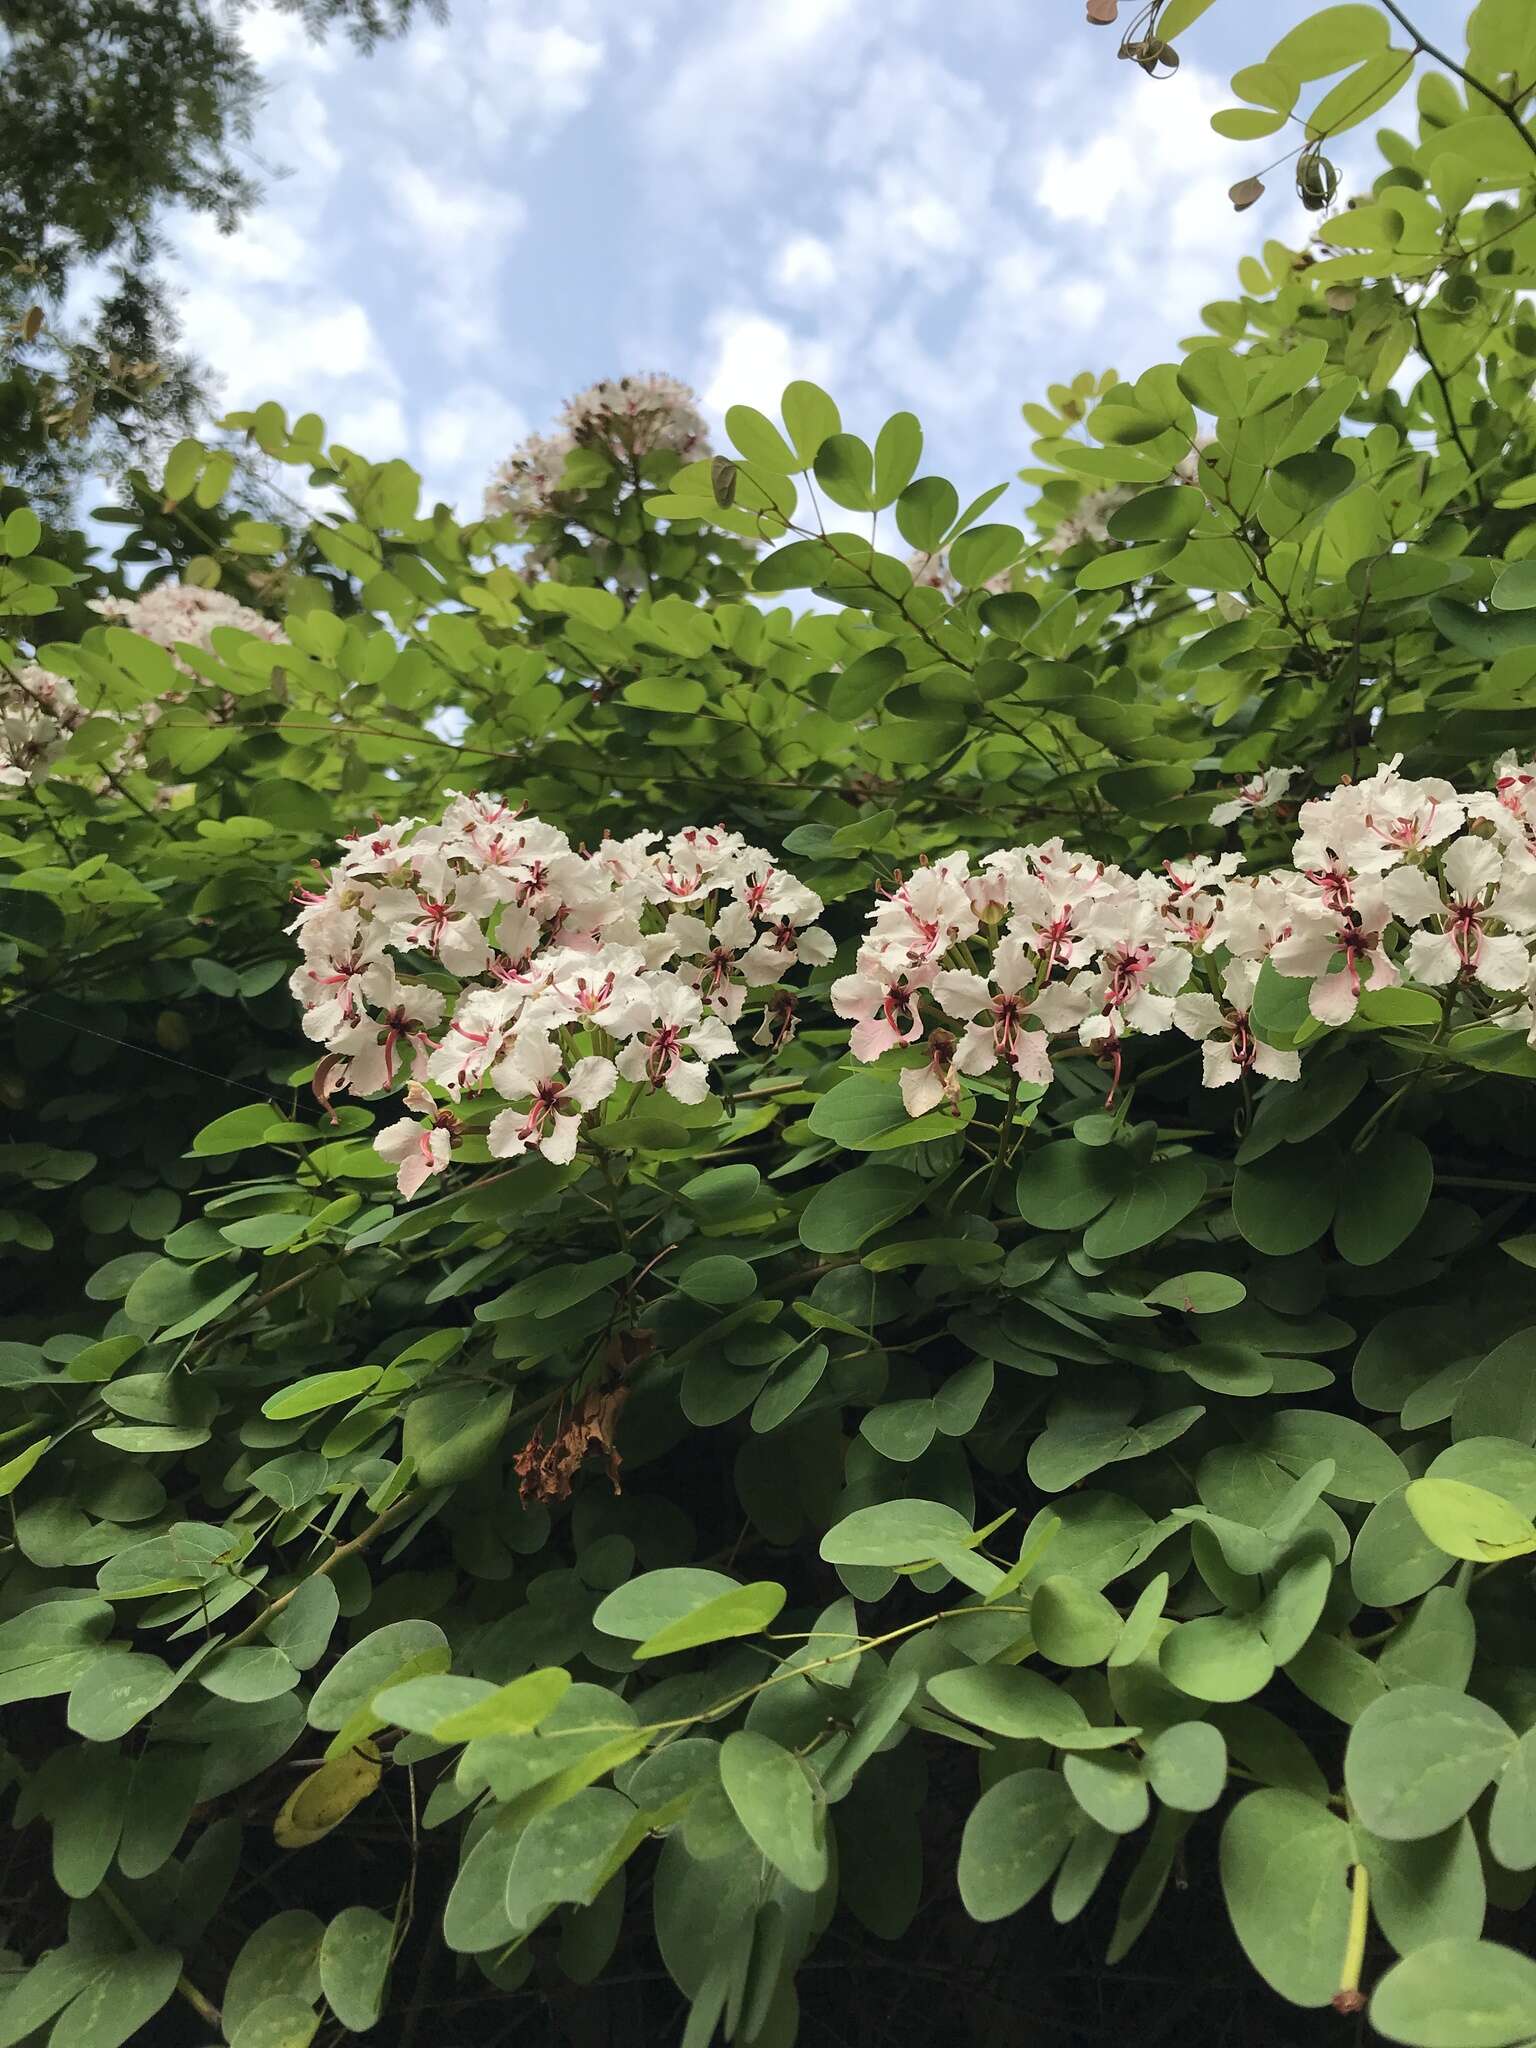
top-left (0, 0), bottom-right (442, 514)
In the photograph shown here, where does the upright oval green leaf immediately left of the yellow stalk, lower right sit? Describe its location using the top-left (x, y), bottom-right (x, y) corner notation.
top-left (1221, 1790), bottom-right (1354, 2007)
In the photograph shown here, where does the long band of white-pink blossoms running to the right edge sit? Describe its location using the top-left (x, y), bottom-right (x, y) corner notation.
top-left (847, 756), bottom-right (1536, 1116)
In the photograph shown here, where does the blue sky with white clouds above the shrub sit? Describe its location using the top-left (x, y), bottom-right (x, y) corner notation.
top-left (172, 0), bottom-right (1464, 512)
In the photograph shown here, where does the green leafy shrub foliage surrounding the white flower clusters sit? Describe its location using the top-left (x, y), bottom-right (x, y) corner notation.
top-left (0, 0), bottom-right (1536, 2048)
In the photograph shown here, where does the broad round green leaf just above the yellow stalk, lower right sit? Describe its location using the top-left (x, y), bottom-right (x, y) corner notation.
top-left (1343, 1686), bottom-right (1516, 1841)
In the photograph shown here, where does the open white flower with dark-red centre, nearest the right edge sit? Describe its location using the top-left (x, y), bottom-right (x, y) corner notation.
top-left (1384, 838), bottom-right (1536, 989)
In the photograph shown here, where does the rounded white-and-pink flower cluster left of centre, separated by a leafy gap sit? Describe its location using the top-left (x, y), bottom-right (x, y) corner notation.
top-left (289, 793), bottom-right (834, 1196)
